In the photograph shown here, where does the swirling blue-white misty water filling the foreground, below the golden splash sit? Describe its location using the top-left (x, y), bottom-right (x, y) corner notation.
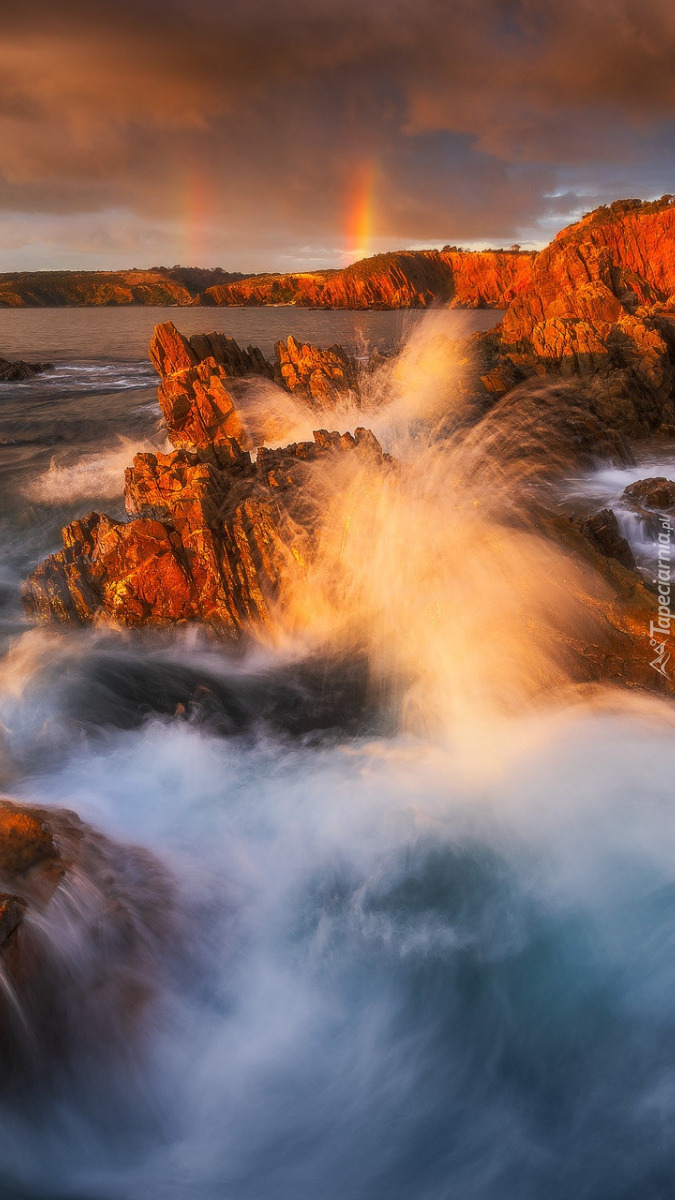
top-left (0, 704), bottom-right (675, 1200)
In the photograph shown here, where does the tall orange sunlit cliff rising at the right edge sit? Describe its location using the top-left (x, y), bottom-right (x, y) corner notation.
top-left (473, 197), bottom-right (675, 437)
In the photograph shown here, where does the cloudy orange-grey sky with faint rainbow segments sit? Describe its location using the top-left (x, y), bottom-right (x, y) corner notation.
top-left (0, 0), bottom-right (675, 271)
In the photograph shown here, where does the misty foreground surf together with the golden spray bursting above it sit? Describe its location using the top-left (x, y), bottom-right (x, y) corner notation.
top-left (0, 320), bottom-right (675, 1200)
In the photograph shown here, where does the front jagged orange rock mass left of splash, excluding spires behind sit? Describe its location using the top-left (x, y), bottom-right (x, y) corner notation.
top-left (24, 430), bottom-right (390, 637)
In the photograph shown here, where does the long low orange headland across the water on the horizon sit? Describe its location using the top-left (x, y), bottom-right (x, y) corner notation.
top-left (0, 250), bottom-right (536, 308)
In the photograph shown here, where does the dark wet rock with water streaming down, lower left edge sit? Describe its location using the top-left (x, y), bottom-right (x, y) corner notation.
top-left (0, 798), bottom-right (177, 1090)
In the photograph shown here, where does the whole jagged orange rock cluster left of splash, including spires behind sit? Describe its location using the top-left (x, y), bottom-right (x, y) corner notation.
top-left (24, 323), bottom-right (387, 636)
